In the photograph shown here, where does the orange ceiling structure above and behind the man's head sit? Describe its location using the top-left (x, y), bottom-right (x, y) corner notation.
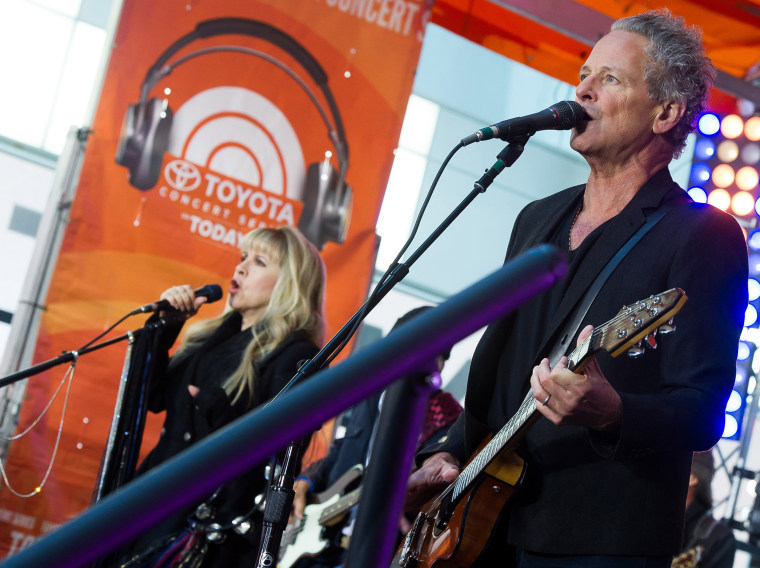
top-left (432, 0), bottom-right (760, 112)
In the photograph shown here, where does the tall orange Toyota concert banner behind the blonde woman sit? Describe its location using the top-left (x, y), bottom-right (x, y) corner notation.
top-left (0, 0), bottom-right (430, 557)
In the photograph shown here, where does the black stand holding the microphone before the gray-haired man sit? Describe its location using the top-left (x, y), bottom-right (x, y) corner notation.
top-left (256, 134), bottom-right (530, 568)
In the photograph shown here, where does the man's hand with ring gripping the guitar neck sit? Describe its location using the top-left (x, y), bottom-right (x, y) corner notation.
top-left (530, 325), bottom-right (622, 433)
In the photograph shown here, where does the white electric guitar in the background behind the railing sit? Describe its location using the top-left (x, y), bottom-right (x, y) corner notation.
top-left (277, 465), bottom-right (364, 568)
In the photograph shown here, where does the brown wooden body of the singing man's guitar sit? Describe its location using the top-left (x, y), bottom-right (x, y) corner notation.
top-left (391, 442), bottom-right (525, 568)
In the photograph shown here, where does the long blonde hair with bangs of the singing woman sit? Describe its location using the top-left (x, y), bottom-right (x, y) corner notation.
top-left (175, 226), bottom-right (325, 403)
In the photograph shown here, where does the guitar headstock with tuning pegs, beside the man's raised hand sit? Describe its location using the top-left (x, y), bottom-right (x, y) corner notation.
top-left (593, 288), bottom-right (687, 357)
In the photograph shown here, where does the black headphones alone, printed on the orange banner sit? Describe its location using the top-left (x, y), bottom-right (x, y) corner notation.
top-left (116, 18), bottom-right (353, 249)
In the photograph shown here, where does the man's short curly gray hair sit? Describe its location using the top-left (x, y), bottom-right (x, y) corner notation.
top-left (612, 8), bottom-right (716, 158)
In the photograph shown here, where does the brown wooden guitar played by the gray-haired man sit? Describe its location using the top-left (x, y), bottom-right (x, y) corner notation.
top-left (391, 288), bottom-right (686, 568)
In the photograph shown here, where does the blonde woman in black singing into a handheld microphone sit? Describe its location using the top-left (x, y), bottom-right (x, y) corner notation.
top-left (117, 227), bottom-right (325, 568)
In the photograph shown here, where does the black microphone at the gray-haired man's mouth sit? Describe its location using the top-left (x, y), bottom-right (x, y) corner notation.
top-left (462, 101), bottom-right (586, 146)
